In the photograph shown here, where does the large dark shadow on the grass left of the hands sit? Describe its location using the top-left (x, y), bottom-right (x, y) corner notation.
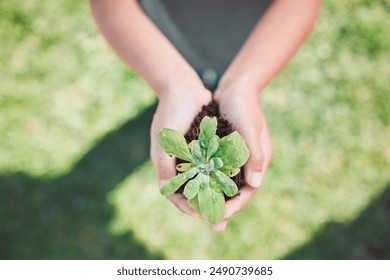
top-left (0, 106), bottom-right (162, 259)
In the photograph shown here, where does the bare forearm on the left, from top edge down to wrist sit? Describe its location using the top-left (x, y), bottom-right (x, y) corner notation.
top-left (89, 0), bottom-right (201, 95)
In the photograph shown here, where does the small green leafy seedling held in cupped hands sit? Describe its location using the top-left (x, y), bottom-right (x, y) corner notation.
top-left (158, 117), bottom-right (249, 224)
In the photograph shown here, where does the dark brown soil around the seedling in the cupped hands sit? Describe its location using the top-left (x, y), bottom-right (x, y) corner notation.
top-left (176, 100), bottom-right (245, 200)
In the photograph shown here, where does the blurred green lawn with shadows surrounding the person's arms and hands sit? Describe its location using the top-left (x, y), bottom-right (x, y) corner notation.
top-left (0, 0), bottom-right (390, 259)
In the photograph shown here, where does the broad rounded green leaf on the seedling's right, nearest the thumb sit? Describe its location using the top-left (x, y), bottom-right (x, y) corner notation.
top-left (214, 131), bottom-right (249, 169)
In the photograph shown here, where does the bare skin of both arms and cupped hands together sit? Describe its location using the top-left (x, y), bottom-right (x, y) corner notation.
top-left (89, 0), bottom-right (321, 232)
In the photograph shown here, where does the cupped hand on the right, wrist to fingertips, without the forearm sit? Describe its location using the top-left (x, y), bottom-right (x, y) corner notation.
top-left (211, 84), bottom-right (272, 231)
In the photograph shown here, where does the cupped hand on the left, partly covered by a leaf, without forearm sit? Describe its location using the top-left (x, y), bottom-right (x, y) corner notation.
top-left (150, 85), bottom-right (211, 218)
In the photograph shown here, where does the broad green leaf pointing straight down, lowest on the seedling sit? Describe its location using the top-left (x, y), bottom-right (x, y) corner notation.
top-left (198, 185), bottom-right (225, 224)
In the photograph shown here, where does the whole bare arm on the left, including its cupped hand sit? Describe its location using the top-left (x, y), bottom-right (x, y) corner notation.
top-left (89, 0), bottom-right (211, 221)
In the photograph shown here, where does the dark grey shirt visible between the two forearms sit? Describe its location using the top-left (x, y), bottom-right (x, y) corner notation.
top-left (139, 0), bottom-right (271, 73)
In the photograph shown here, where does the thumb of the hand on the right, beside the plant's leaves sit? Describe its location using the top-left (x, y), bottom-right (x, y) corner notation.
top-left (242, 127), bottom-right (264, 188)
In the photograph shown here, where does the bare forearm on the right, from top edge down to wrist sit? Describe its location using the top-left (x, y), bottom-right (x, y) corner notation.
top-left (218, 0), bottom-right (321, 93)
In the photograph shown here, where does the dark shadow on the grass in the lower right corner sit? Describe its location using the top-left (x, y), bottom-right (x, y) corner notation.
top-left (285, 183), bottom-right (390, 260)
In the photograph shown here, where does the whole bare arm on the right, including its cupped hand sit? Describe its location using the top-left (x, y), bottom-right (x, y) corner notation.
top-left (214, 0), bottom-right (321, 230)
